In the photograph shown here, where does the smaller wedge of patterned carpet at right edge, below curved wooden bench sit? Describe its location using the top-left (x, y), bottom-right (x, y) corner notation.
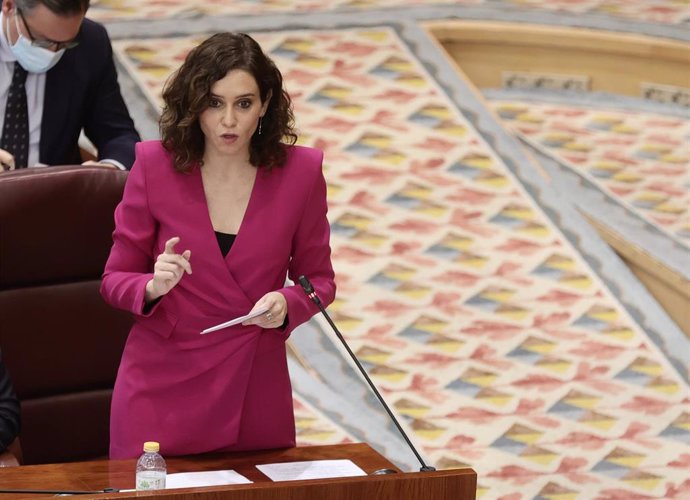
top-left (492, 101), bottom-right (690, 248)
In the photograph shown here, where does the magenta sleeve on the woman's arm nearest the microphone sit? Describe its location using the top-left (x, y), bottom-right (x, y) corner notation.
top-left (280, 152), bottom-right (335, 335)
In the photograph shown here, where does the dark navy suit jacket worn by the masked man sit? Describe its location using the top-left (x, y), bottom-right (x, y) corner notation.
top-left (39, 19), bottom-right (140, 169)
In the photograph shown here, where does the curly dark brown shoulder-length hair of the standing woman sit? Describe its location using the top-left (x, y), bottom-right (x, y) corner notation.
top-left (159, 33), bottom-right (297, 172)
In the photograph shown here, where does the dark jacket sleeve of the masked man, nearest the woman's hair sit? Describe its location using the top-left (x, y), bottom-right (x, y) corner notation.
top-left (84, 21), bottom-right (140, 169)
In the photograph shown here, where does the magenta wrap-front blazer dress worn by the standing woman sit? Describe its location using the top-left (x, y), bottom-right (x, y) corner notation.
top-left (101, 141), bottom-right (335, 459)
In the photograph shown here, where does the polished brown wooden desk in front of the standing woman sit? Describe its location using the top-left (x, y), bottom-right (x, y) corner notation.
top-left (0, 444), bottom-right (477, 500)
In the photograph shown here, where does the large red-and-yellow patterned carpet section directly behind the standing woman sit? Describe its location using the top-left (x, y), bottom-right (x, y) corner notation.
top-left (115, 28), bottom-right (690, 499)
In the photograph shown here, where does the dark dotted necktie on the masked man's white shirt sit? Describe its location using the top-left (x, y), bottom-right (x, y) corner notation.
top-left (0, 62), bottom-right (29, 168)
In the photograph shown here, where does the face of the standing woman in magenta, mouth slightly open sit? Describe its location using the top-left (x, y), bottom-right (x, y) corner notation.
top-left (199, 69), bottom-right (269, 159)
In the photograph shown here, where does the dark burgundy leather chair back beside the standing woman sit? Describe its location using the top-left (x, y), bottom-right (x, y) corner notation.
top-left (0, 166), bottom-right (132, 464)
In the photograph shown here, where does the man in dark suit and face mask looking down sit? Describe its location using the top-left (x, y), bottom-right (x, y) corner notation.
top-left (0, 0), bottom-right (140, 170)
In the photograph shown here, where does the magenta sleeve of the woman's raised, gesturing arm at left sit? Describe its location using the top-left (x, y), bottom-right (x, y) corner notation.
top-left (101, 144), bottom-right (157, 315)
